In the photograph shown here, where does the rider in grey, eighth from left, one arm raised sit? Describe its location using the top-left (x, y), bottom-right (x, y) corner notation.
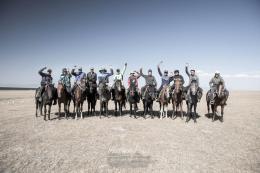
top-left (140, 68), bottom-right (157, 99)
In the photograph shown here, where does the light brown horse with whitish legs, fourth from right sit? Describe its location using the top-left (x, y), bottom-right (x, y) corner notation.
top-left (158, 85), bottom-right (170, 119)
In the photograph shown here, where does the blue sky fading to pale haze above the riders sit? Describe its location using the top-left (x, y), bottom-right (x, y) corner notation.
top-left (0, 0), bottom-right (260, 90)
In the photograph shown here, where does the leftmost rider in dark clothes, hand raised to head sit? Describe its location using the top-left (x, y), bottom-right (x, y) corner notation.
top-left (37, 67), bottom-right (57, 105)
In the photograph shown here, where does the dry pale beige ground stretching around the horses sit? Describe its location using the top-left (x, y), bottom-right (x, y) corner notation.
top-left (0, 91), bottom-right (260, 173)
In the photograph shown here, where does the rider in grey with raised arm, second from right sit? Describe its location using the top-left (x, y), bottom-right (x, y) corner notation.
top-left (185, 63), bottom-right (202, 102)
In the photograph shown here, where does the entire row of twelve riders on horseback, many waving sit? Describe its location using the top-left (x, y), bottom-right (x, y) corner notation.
top-left (36, 62), bottom-right (228, 109)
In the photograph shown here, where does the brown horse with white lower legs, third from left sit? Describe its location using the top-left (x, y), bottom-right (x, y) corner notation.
top-left (74, 79), bottom-right (86, 120)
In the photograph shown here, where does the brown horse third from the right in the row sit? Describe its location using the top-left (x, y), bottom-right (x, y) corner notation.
top-left (172, 79), bottom-right (183, 119)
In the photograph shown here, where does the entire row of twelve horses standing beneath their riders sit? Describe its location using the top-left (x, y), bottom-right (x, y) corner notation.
top-left (35, 80), bottom-right (228, 122)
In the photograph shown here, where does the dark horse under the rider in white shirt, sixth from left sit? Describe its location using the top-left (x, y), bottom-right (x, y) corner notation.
top-left (114, 80), bottom-right (126, 116)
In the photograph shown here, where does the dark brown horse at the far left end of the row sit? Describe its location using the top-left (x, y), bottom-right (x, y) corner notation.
top-left (42, 84), bottom-right (55, 121)
